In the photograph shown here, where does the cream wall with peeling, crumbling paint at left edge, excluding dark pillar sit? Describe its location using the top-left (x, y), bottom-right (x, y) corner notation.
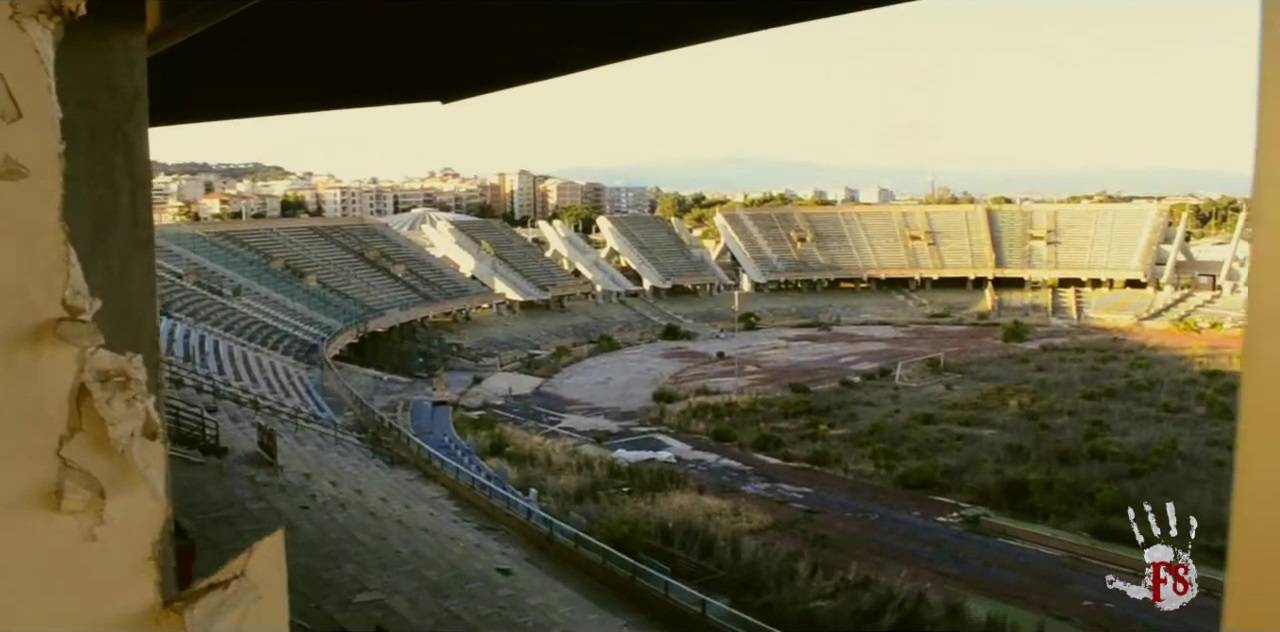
top-left (0, 0), bottom-right (288, 632)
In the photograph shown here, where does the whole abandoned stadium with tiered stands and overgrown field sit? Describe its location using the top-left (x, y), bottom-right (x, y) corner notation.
top-left (162, 202), bottom-right (1249, 631)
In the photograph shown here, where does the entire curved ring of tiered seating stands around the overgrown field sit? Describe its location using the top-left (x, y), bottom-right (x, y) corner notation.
top-left (142, 205), bottom-right (1248, 629)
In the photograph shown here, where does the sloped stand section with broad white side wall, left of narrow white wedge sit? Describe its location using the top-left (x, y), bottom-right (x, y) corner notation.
top-left (388, 209), bottom-right (591, 303)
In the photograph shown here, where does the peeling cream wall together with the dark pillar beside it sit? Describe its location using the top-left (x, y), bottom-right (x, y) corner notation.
top-left (0, 0), bottom-right (288, 631)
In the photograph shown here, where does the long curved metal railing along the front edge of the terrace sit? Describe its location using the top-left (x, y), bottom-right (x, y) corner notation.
top-left (320, 337), bottom-right (780, 632)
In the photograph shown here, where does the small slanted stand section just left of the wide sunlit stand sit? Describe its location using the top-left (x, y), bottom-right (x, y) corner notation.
top-left (595, 215), bottom-right (732, 290)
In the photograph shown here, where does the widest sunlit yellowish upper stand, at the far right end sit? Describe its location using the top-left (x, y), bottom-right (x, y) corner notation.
top-left (716, 202), bottom-right (1166, 287)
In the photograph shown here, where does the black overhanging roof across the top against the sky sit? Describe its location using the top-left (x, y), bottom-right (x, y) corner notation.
top-left (147, 0), bottom-right (904, 127)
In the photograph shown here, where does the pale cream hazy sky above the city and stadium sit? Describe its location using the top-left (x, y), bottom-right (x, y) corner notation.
top-left (151, 0), bottom-right (1260, 193)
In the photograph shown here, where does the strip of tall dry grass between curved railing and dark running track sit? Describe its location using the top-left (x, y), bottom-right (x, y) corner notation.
top-left (460, 418), bottom-right (1009, 631)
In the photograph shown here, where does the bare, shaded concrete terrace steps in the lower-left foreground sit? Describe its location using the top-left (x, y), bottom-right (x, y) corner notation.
top-left (170, 399), bottom-right (655, 631)
